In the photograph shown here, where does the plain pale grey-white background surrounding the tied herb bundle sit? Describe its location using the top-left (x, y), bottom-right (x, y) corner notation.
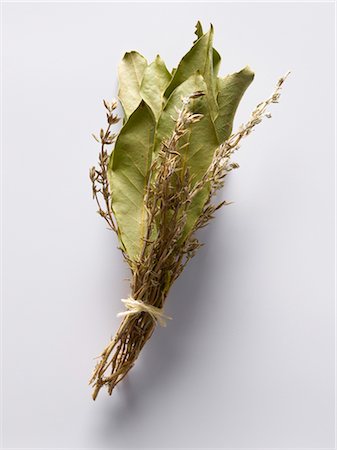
top-left (2, 3), bottom-right (334, 449)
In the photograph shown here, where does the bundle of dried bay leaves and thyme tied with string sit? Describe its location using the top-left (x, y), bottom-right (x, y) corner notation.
top-left (90, 22), bottom-right (285, 400)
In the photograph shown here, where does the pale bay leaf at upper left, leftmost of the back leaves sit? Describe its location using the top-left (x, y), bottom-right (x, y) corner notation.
top-left (118, 51), bottom-right (147, 122)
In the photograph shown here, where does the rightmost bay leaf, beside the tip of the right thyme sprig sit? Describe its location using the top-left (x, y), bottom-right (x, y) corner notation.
top-left (215, 66), bottom-right (254, 142)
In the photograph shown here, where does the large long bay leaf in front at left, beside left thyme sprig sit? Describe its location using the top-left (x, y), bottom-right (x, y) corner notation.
top-left (108, 101), bottom-right (155, 260)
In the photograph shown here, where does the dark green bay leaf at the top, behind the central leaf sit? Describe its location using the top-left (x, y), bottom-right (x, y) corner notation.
top-left (165, 25), bottom-right (217, 118)
